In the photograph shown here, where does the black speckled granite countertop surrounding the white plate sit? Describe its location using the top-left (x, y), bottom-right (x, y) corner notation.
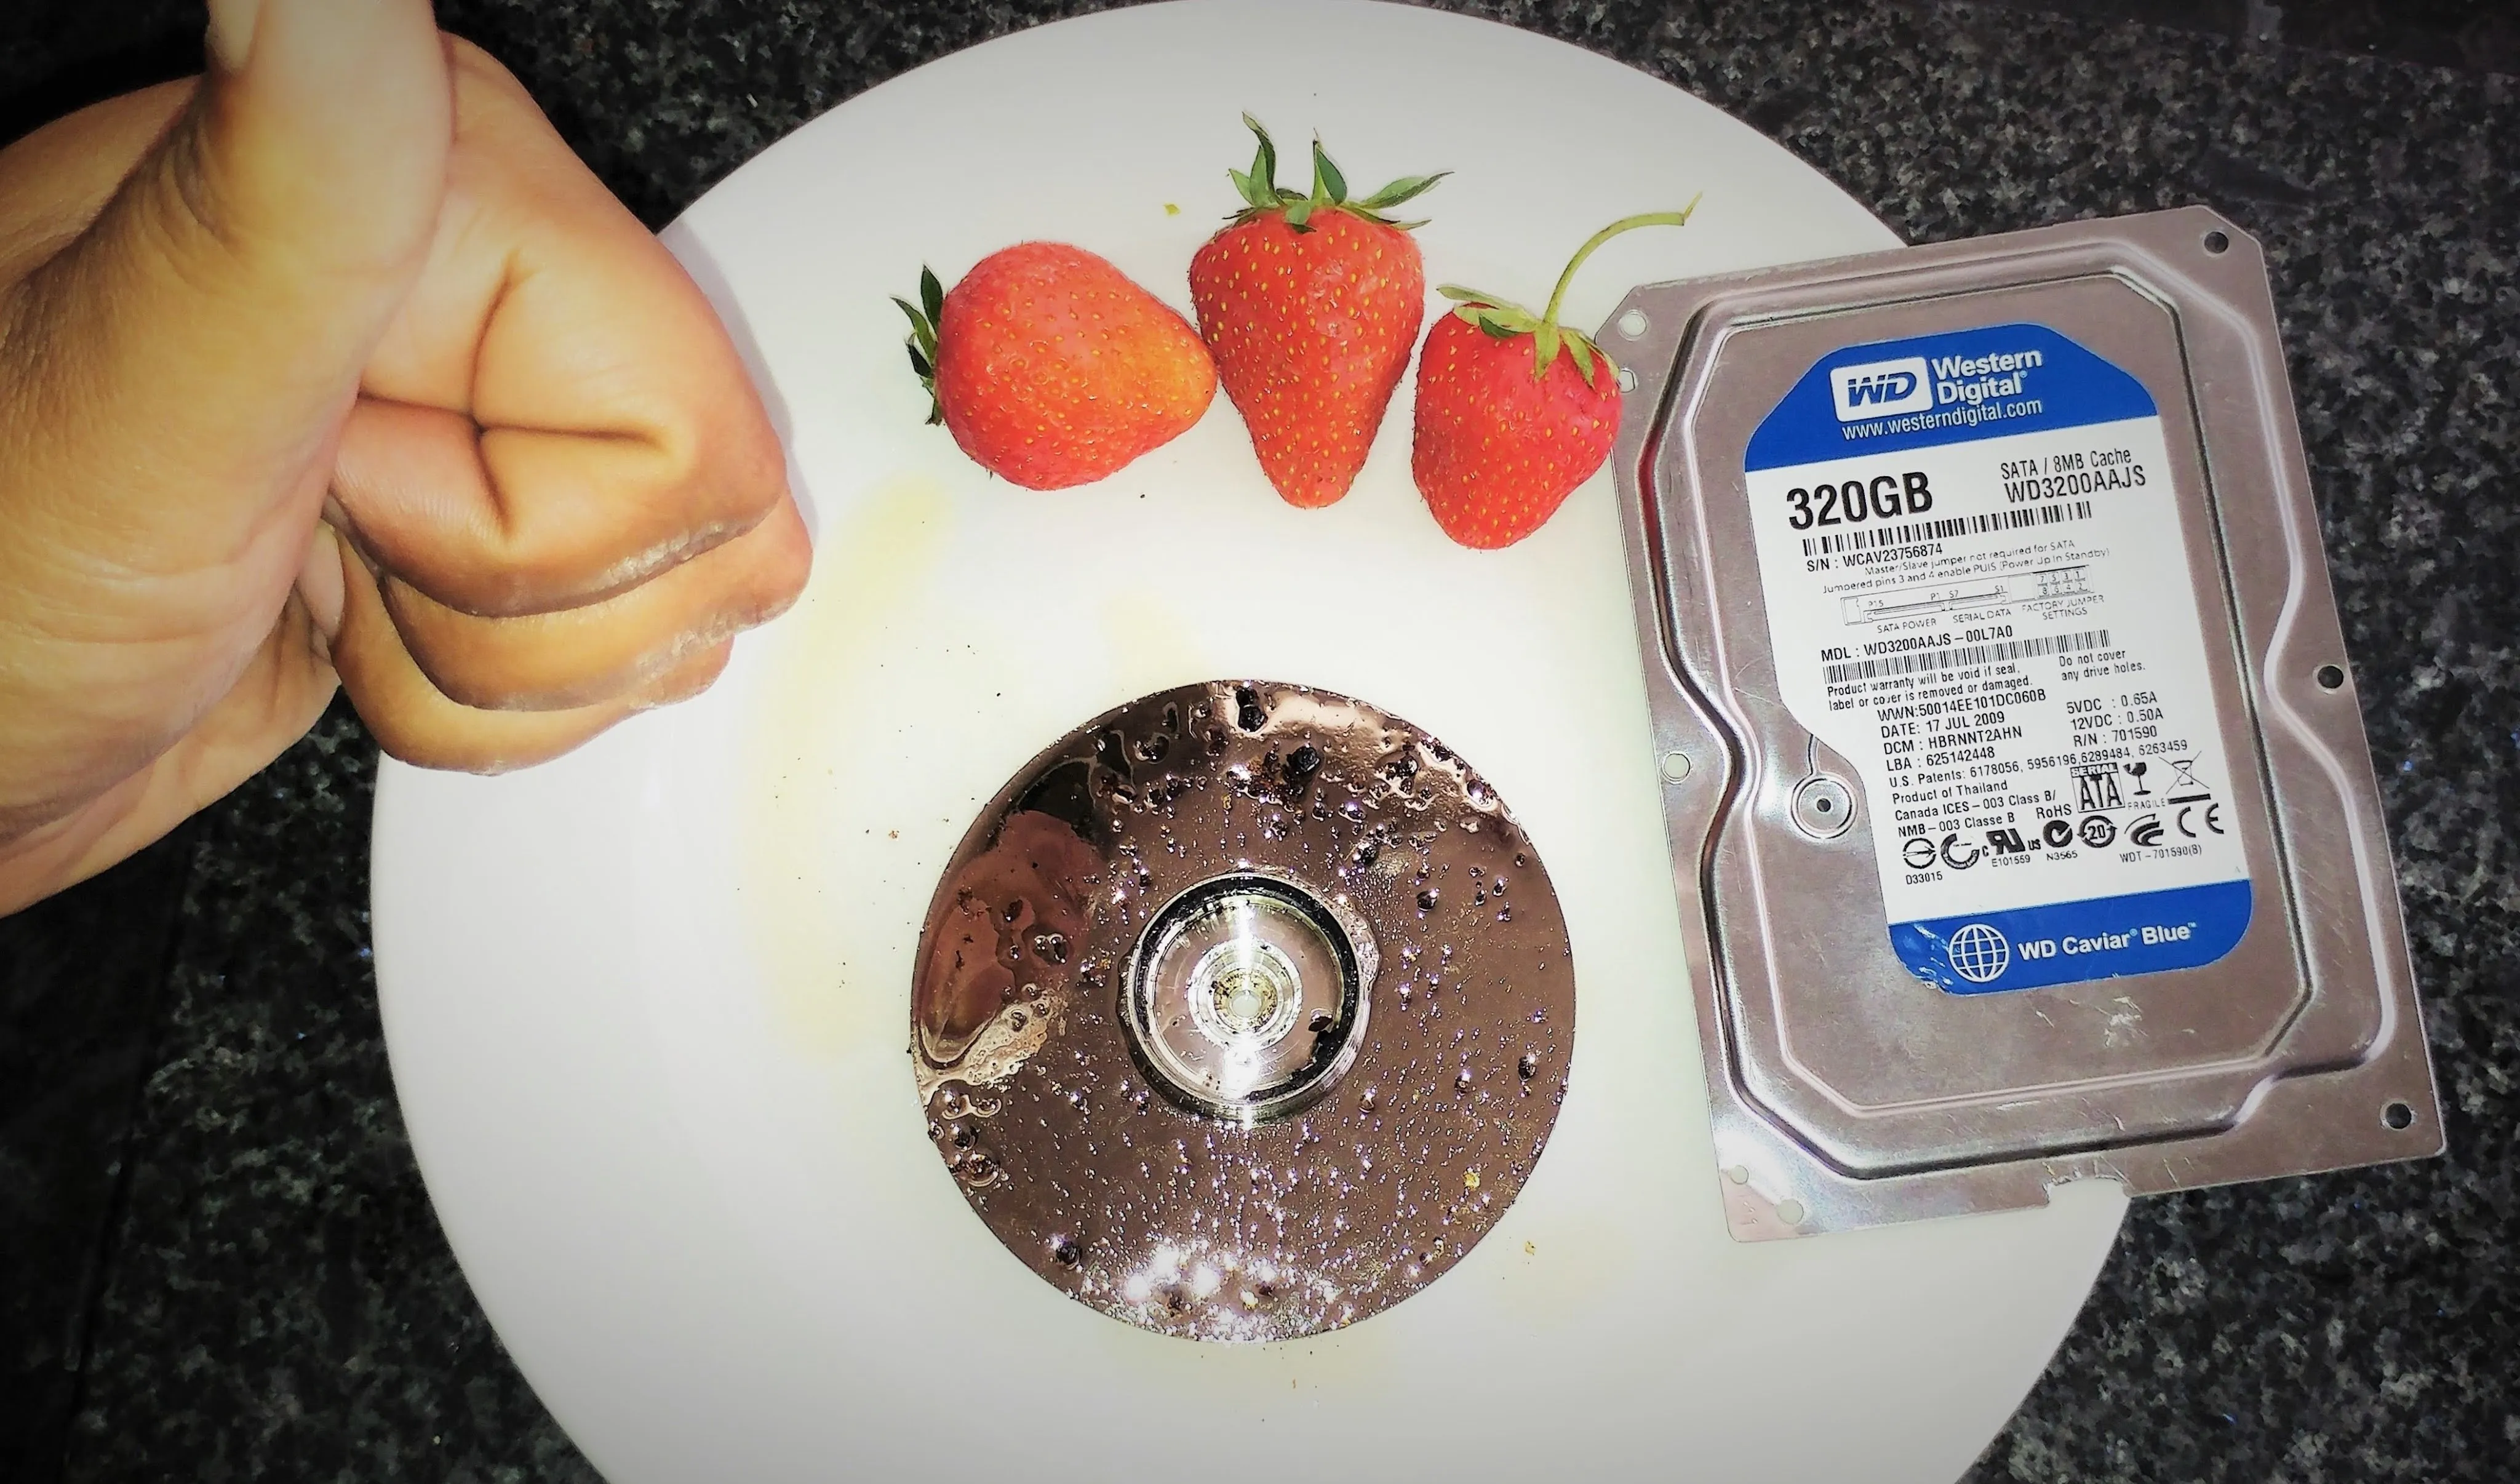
top-left (0, 0), bottom-right (2520, 1484)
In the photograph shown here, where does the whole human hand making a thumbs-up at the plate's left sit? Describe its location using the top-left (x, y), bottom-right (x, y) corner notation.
top-left (0, 0), bottom-right (809, 912)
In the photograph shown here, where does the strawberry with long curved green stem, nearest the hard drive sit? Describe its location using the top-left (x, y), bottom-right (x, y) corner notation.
top-left (1409, 202), bottom-right (1696, 549)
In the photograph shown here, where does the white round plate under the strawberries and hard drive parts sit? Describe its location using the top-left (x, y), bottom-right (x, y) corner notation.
top-left (375, 2), bottom-right (2124, 1484)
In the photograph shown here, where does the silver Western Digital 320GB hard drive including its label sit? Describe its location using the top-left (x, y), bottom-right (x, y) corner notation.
top-left (1603, 209), bottom-right (2442, 1240)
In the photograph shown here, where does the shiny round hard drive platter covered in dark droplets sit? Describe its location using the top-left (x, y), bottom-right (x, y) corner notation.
top-left (910, 680), bottom-right (1575, 1341)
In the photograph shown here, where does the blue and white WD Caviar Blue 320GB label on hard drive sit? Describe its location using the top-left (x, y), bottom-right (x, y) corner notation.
top-left (1747, 325), bottom-right (2251, 995)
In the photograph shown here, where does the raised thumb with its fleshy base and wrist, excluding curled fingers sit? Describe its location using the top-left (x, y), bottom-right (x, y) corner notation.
top-left (0, 0), bottom-right (451, 871)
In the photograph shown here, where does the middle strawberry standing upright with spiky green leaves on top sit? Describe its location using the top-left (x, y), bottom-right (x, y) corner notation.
top-left (1189, 113), bottom-right (1444, 506)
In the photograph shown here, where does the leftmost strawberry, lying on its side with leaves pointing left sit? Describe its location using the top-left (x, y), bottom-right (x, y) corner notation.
top-left (892, 242), bottom-right (1217, 489)
